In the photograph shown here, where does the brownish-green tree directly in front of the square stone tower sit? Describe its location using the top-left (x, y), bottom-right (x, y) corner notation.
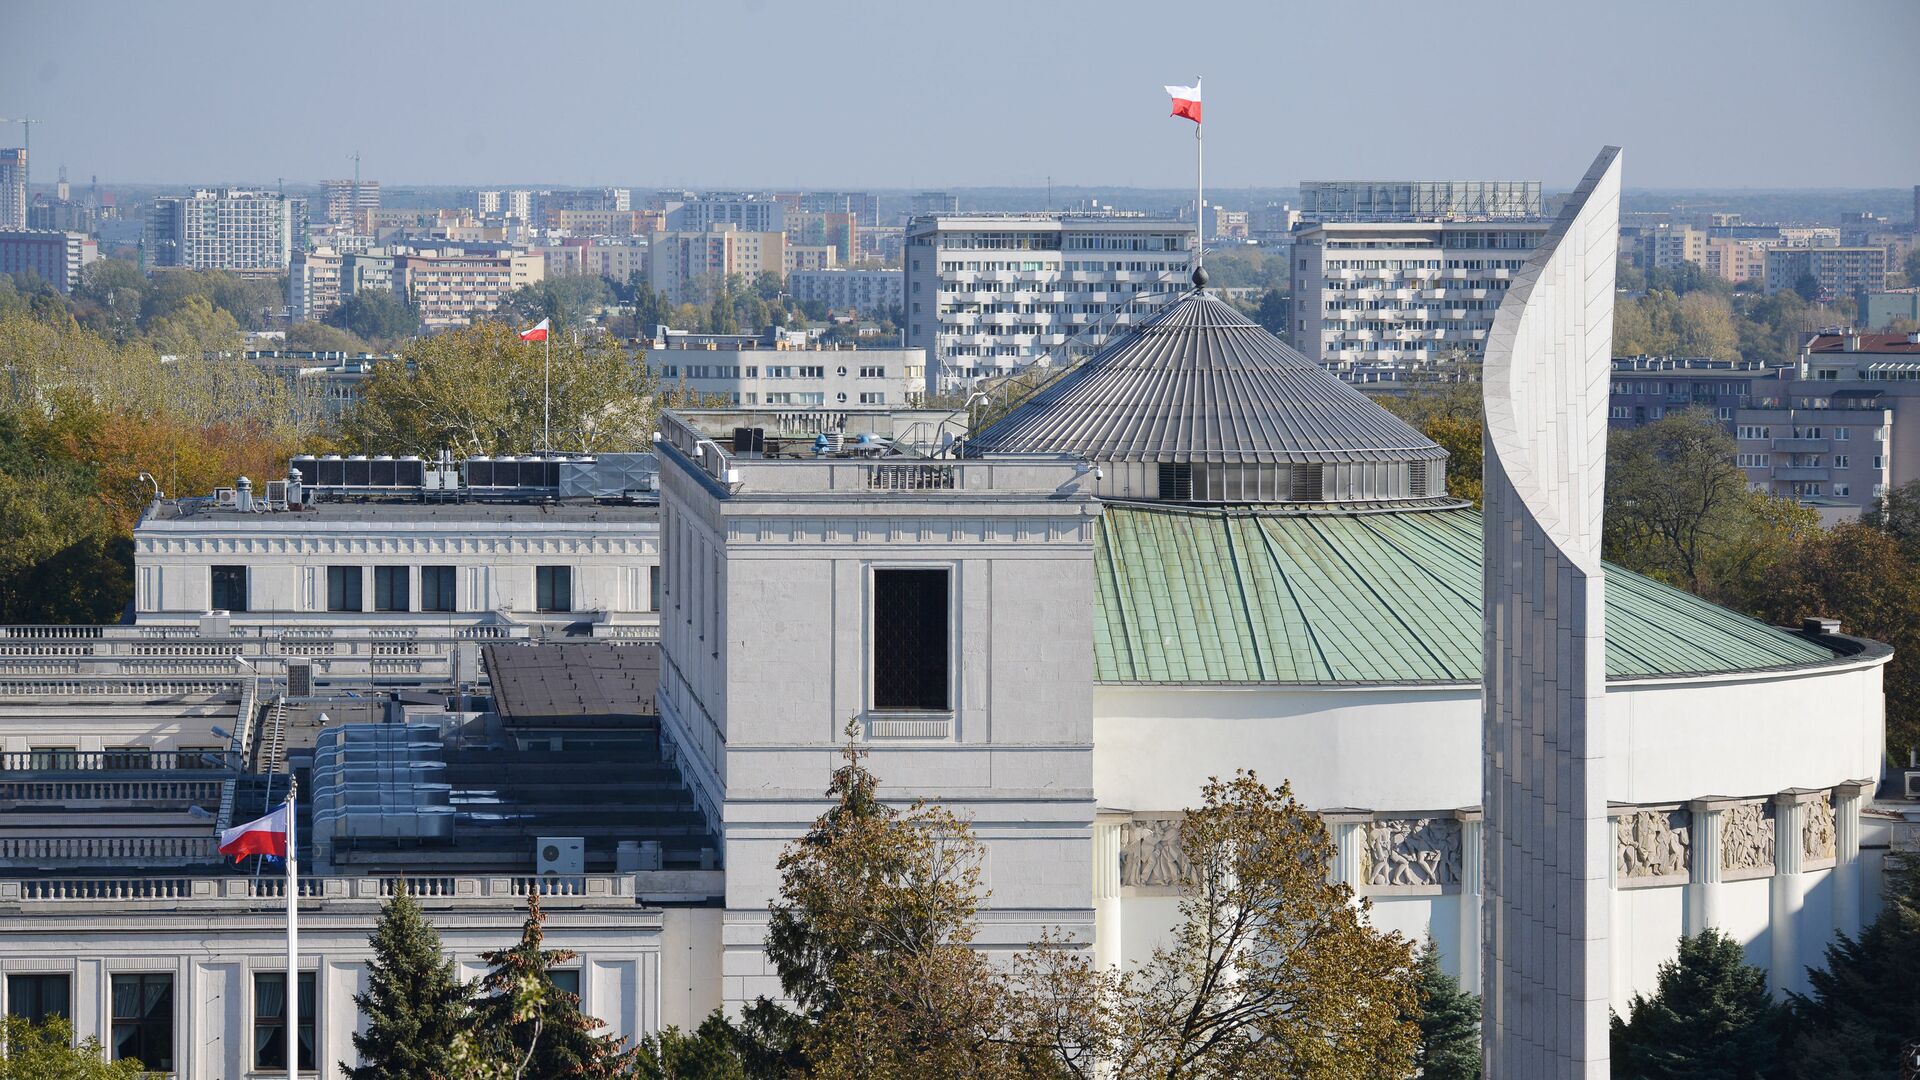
top-left (766, 724), bottom-right (1021, 1076)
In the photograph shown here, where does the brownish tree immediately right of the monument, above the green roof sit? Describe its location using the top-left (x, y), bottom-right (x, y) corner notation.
top-left (1605, 409), bottom-right (1751, 594)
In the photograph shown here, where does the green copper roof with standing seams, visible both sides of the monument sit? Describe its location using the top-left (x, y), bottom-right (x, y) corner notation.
top-left (1094, 505), bottom-right (1837, 682)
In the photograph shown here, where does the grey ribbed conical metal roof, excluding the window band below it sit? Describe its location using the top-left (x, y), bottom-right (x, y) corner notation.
top-left (966, 288), bottom-right (1444, 465)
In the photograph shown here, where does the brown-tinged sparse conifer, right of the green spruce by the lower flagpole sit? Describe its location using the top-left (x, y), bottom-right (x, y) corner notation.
top-left (474, 892), bottom-right (634, 1080)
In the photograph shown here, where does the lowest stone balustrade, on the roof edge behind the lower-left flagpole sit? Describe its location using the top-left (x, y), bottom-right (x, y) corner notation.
top-left (0, 871), bottom-right (726, 909)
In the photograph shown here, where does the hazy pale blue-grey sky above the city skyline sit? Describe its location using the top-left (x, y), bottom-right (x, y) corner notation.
top-left (0, 0), bottom-right (1920, 188)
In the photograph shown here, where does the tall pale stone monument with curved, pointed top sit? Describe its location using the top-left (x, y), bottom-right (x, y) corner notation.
top-left (1480, 146), bottom-right (1620, 1080)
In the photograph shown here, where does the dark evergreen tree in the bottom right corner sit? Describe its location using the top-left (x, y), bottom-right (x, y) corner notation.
top-left (1789, 853), bottom-right (1920, 1080)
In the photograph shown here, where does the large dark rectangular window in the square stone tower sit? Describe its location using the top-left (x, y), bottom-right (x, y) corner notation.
top-left (874, 567), bottom-right (952, 711)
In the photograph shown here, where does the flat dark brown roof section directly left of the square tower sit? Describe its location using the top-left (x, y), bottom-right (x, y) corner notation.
top-left (486, 642), bottom-right (660, 723)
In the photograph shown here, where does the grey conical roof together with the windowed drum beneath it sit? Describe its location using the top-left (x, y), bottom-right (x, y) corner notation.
top-left (966, 288), bottom-right (1446, 503)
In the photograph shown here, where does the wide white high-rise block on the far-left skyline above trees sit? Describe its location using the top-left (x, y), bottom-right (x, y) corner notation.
top-left (146, 188), bottom-right (307, 275)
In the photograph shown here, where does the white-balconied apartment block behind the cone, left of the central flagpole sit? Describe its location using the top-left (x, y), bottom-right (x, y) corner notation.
top-left (904, 213), bottom-right (1194, 394)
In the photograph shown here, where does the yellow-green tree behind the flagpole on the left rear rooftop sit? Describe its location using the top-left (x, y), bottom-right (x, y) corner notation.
top-left (346, 321), bottom-right (655, 455)
